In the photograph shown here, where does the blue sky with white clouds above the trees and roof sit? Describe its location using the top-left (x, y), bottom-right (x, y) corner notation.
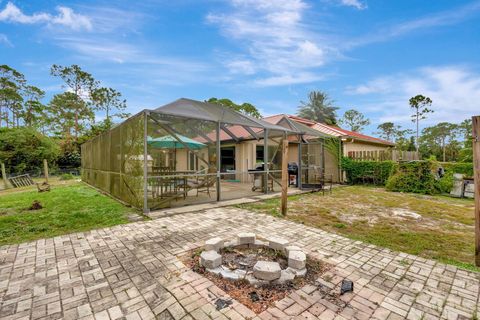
top-left (0, 0), bottom-right (480, 134)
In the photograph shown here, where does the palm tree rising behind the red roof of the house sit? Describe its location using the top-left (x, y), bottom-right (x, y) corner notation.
top-left (297, 91), bottom-right (338, 125)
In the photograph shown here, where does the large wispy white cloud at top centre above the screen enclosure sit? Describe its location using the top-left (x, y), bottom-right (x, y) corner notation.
top-left (207, 0), bottom-right (335, 86)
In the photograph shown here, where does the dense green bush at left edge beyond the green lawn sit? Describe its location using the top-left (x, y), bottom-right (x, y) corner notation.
top-left (0, 127), bottom-right (60, 173)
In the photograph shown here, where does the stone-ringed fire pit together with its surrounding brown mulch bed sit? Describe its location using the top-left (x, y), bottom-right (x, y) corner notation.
top-left (182, 233), bottom-right (334, 314)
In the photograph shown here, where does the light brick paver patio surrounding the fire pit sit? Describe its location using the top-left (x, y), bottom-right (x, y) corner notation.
top-left (0, 208), bottom-right (480, 319)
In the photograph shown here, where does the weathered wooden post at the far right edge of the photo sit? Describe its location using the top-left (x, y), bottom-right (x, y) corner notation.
top-left (472, 116), bottom-right (480, 267)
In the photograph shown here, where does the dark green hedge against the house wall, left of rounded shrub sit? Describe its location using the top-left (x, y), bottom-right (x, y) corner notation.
top-left (342, 157), bottom-right (396, 185)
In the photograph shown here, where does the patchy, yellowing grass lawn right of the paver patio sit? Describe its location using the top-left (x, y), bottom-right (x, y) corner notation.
top-left (240, 186), bottom-right (480, 271)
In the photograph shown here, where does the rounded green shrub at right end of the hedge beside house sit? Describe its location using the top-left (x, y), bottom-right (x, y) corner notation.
top-left (386, 160), bottom-right (441, 194)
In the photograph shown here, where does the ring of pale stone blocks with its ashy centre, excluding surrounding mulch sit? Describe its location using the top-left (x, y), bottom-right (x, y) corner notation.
top-left (200, 233), bottom-right (307, 285)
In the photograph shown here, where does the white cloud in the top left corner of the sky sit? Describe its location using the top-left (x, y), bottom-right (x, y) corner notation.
top-left (0, 2), bottom-right (92, 30)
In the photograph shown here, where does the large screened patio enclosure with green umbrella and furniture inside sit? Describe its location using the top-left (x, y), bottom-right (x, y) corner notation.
top-left (82, 99), bottom-right (321, 212)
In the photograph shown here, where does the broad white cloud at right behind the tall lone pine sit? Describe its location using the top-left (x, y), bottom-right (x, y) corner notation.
top-left (347, 66), bottom-right (480, 125)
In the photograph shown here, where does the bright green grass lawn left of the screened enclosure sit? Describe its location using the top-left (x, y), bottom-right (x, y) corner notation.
top-left (0, 181), bottom-right (139, 245)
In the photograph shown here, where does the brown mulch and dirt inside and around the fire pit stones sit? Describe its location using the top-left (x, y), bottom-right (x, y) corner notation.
top-left (182, 247), bottom-right (332, 314)
